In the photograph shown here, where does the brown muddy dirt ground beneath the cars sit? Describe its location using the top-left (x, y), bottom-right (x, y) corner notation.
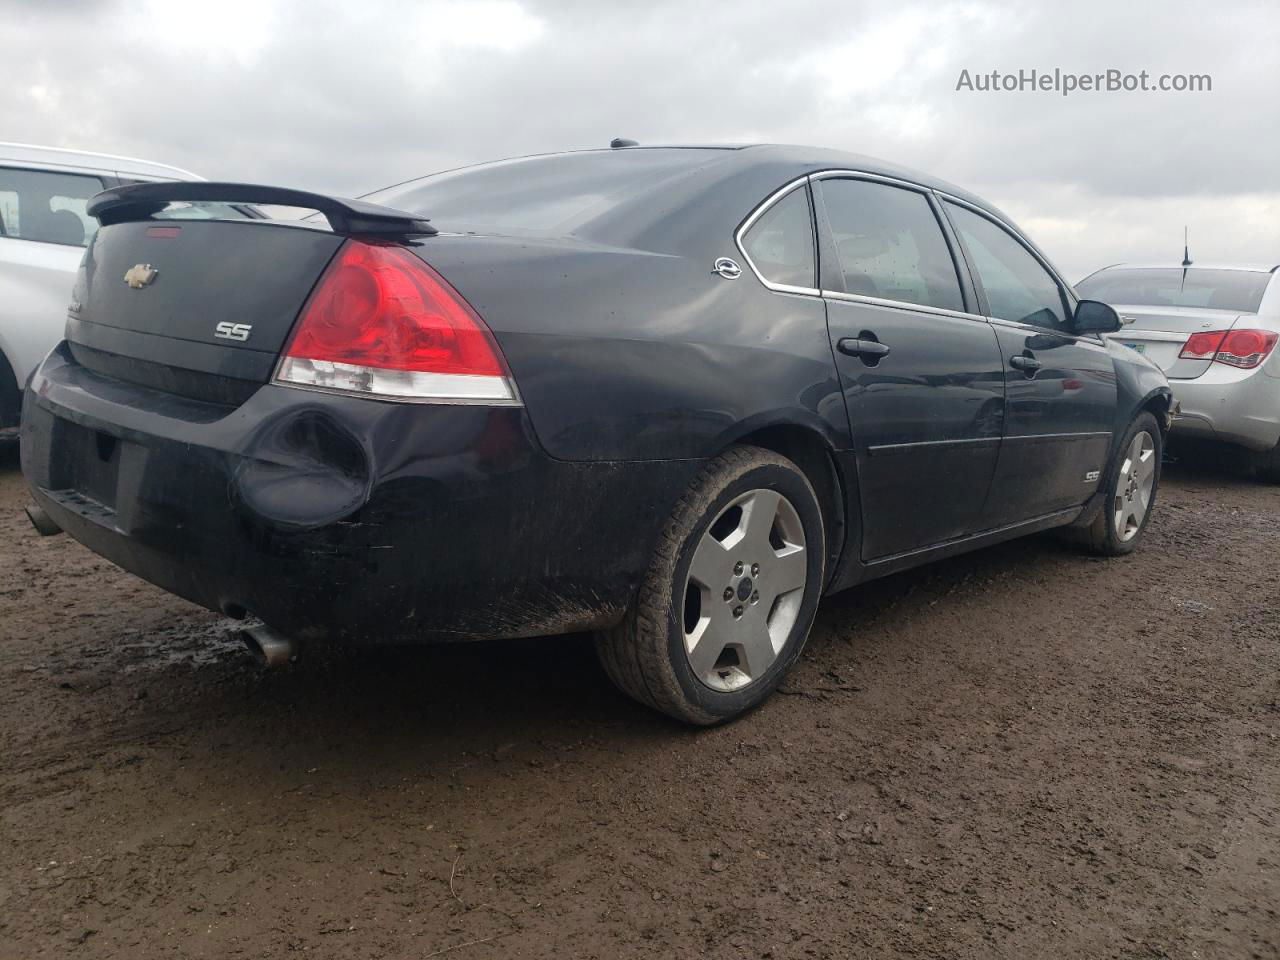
top-left (0, 452), bottom-right (1280, 960)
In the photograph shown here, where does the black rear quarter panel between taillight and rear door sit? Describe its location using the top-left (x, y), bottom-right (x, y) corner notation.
top-left (417, 231), bottom-right (849, 461)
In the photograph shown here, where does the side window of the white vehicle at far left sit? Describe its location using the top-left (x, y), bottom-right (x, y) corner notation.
top-left (0, 166), bottom-right (104, 247)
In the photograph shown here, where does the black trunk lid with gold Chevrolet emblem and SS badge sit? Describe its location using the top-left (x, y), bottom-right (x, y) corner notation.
top-left (67, 220), bottom-right (343, 406)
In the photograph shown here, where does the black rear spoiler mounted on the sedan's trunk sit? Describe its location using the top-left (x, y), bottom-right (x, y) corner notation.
top-left (86, 180), bottom-right (438, 237)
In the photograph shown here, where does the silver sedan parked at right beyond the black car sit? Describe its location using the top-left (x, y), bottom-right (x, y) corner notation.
top-left (1075, 264), bottom-right (1280, 483)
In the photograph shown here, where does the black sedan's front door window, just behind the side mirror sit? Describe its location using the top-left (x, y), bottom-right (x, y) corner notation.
top-left (947, 202), bottom-right (1070, 333)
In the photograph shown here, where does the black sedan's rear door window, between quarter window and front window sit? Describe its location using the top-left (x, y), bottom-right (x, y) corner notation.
top-left (820, 179), bottom-right (964, 312)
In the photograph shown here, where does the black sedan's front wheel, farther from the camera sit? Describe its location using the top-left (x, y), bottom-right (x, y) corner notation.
top-left (1084, 412), bottom-right (1165, 557)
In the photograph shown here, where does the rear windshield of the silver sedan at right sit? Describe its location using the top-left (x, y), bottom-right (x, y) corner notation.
top-left (1075, 266), bottom-right (1271, 314)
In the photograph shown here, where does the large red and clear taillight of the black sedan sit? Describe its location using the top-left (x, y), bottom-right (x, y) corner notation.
top-left (276, 241), bottom-right (516, 402)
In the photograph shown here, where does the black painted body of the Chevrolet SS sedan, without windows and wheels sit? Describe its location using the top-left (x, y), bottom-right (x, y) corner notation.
top-left (22, 147), bottom-right (1170, 641)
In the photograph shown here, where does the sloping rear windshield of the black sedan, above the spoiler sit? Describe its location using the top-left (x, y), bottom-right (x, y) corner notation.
top-left (365, 148), bottom-right (719, 233)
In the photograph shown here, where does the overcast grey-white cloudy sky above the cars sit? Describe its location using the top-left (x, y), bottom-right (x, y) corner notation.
top-left (0, 0), bottom-right (1280, 280)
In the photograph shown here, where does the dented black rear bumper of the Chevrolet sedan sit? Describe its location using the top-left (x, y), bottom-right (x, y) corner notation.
top-left (22, 344), bottom-right (698, 643)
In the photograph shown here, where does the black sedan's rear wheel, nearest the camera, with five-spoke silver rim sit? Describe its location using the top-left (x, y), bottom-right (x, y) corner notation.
top-left (596, 447), bottom-right (826, 726)
